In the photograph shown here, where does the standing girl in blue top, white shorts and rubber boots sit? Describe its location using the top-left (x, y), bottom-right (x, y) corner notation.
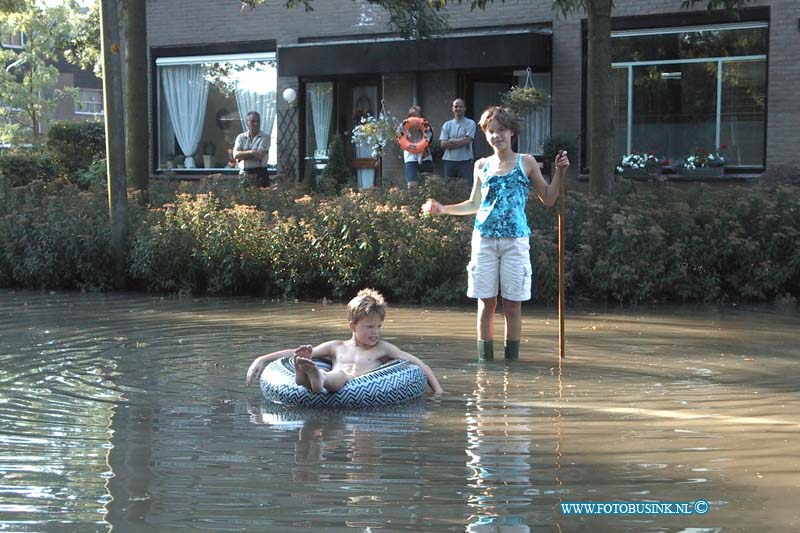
top-left (422, 107), bottom-right (569, 360)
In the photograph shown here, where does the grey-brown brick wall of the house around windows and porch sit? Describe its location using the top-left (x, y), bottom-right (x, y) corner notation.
top-left (147, 0), bottom-right (800, 176)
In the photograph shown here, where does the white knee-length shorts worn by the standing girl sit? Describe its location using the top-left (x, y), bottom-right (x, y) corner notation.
top-left (467, 231), bottom-right (533, 302)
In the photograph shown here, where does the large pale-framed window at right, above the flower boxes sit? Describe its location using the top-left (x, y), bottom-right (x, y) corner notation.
top-left (612, 22), bottom-right (768, 168)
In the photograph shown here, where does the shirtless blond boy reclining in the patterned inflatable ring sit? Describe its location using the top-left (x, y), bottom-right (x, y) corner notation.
top-left (245, 289), bottom-right (444, 394)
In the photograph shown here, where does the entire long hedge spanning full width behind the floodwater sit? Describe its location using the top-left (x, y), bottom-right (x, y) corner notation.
top-left (0, 177), bottom-right (800, 304)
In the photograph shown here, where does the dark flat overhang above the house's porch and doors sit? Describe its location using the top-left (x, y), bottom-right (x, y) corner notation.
top-left (278, 31), bottom-right (552, 77)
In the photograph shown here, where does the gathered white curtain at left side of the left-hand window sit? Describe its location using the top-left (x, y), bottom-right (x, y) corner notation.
top-left (161, 65), bottom-right (208, 168)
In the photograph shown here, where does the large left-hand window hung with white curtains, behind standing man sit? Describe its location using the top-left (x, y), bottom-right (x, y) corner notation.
top-left (156, 52), bottom-right (277, 170)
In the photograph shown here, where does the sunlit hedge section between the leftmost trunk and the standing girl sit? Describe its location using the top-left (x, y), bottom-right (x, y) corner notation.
top-left (129, 180), bottom-right (468, 302)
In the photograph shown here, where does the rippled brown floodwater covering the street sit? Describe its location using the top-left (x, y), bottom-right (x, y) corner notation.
top-left (0, 291), bottom-right (800, 532)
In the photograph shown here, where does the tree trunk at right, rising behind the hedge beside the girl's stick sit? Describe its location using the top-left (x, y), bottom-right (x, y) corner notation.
top-left (586, 0), bottom-right (614, 194)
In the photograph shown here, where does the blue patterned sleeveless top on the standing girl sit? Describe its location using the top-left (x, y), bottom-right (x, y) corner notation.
top-left (475, 154), bottom-right (531, 238)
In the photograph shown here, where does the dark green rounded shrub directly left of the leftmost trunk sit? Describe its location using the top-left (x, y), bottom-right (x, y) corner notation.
top-left (47, 120), bottom-right (106, 182)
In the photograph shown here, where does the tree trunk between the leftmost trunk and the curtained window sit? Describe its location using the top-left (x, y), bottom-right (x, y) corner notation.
top-left (125, 0), bottom-right (150, 198)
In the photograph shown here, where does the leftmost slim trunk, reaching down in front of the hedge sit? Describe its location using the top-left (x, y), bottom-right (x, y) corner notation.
top-left (100, 0), bottom-right (128, 289)
